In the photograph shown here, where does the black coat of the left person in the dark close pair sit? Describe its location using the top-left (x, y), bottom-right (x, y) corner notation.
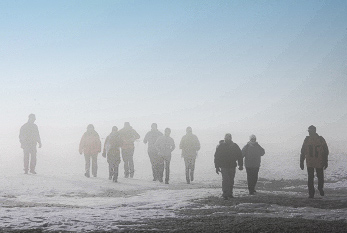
top-left (214, 141), bottom-right (243, 168)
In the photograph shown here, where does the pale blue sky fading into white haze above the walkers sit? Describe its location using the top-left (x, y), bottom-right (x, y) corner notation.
top-left (0, 0), bottom-right (347, 149)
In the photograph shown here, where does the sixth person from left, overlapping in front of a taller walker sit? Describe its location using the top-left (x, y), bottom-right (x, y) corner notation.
top-left (154, 128), bottom-right (175, 184)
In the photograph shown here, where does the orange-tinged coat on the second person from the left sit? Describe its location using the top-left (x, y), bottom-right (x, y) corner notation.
top-left (79, 131), bottom-right (101, 155)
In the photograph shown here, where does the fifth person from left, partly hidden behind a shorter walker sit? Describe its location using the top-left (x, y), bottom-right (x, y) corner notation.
top-left (143, 123), bottom-right (163, 181)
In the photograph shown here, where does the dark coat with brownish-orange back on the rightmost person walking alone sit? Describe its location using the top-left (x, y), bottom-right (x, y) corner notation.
top-left (300, 134), bottom-right (329, 168)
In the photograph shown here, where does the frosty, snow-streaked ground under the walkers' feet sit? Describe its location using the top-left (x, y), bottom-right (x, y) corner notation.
top-left (0, 153), bottom-right (347, 232)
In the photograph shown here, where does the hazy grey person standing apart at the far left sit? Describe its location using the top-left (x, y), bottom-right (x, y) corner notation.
top-left (19, 114), bottom-right (42, 174)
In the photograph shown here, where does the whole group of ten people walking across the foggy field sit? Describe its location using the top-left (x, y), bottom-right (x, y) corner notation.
top-left (19, 114), bottom-right (329, 199)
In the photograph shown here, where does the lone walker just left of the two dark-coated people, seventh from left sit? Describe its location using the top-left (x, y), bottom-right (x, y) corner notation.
top-left (180, 127), bottom-right (200, 184)
